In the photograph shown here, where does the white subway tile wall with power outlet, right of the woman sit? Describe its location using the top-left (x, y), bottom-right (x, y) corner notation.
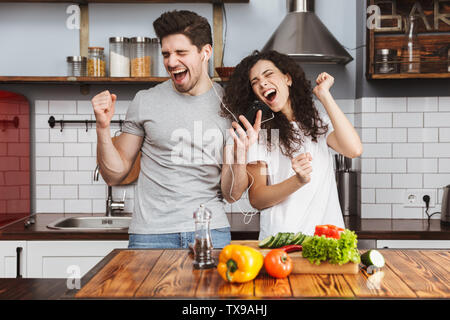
top-left (355, 97), bottom-right (450, 219)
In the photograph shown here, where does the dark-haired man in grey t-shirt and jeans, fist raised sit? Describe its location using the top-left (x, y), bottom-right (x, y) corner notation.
top-left (92, 11), bottom-right (261, 248)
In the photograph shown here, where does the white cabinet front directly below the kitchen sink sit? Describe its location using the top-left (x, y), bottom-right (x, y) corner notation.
top-left (27, 241), bottom-right (128, 279)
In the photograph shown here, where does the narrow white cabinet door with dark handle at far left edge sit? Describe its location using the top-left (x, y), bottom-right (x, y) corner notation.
top-left (0, 241), bottom-right (27, 278)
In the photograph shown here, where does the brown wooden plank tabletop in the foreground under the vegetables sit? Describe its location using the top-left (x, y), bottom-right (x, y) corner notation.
top-left (63, 249), bottom-right (450, 299)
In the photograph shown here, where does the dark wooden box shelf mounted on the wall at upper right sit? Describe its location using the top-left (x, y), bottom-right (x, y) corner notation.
top-left (366, 0), bottom-right (450, 80)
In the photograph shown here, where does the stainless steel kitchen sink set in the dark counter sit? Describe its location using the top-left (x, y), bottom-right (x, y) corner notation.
top-left (47, 217), bottom-right (131, 231)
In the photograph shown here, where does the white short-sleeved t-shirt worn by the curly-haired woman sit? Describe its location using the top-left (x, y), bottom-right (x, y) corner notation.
top-left (247, 112), bottom-right (345, 240)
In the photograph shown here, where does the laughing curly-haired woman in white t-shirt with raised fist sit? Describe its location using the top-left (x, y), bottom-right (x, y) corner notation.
top-left (222, 51), bottom-right (362, 240)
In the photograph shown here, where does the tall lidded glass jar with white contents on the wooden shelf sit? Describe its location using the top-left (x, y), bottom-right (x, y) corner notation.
top-left (109, 37), bottom-right (130, 77)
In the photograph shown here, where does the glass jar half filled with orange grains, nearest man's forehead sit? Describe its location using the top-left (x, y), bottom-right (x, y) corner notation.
top-left (130, 37), bottom-right (151, 77)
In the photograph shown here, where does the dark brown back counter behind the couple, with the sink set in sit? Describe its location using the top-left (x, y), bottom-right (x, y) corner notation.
top-left (0, 213), bottom-right (450, 240)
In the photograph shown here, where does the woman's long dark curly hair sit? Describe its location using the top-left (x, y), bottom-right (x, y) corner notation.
top-left (221, 50), bottom-right (328, 157)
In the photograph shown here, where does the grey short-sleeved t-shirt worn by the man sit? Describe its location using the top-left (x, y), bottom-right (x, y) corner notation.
top-left (123, 80), bottom-right (231, 234)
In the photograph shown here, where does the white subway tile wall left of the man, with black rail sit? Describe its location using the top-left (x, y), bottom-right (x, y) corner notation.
top-left (34, 100), bottom-right (135, 214)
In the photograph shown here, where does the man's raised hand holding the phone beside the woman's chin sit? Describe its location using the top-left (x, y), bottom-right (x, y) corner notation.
top-left (229, 110), bottom-right (262, 164)
